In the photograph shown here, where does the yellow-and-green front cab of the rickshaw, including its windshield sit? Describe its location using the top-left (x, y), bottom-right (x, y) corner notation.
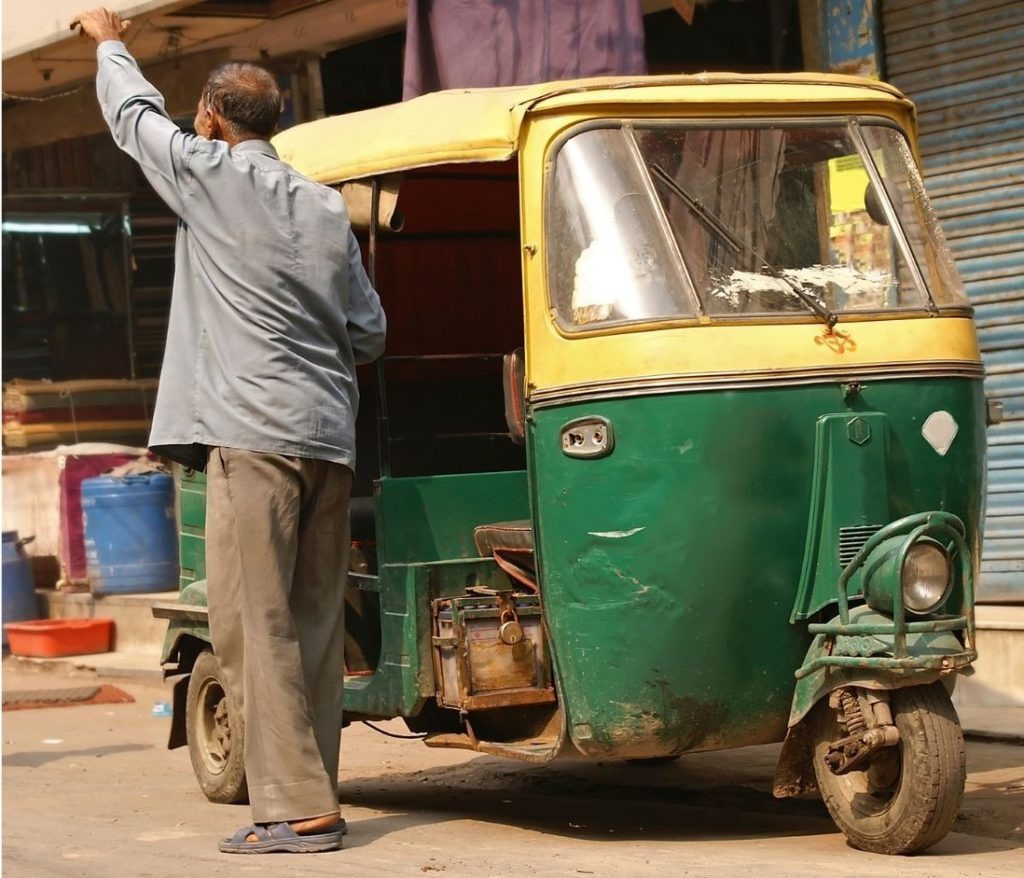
top-left (509, 83), bottom-right (986, 759)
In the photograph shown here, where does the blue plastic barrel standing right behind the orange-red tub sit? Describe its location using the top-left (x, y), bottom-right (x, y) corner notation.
top-left (82, 472), bottom-right (178, 594)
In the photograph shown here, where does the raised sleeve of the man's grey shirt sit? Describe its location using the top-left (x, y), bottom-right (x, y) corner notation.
top-left (96, 40), bottom-right (199, 217)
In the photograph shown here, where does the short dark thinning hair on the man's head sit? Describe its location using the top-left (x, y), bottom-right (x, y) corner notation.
top-left (203, 61), bottom-right (281, 137)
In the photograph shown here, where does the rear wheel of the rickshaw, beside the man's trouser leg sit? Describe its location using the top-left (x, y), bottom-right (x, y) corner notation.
top-left (185, 650), bottom-right (249, 804)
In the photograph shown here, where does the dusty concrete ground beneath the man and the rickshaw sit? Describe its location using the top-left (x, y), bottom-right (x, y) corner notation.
top-left (2, 658), bottom-right (1024, 878)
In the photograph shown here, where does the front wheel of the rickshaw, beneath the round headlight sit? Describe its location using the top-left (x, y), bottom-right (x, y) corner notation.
top-left (812, 682), bottom-right (967, 854)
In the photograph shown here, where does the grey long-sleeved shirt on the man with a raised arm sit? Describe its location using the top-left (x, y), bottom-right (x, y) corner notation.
top-left (96, 40), bottom-right (385, 468)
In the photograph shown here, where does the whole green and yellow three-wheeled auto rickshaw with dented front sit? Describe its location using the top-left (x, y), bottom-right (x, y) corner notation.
top-left (156, 74), bottom-right (989, 853)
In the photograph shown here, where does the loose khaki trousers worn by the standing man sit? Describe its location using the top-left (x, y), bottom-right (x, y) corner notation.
top-left (206, 448), bottom-right (352, 823)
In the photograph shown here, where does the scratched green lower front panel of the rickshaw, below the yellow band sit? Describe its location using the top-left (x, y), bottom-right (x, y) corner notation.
top-left (531, 378), bottom-right (984, 758)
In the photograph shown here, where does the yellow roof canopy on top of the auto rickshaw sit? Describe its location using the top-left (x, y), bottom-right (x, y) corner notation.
top-left (273, 73), bottom-right (912, 183)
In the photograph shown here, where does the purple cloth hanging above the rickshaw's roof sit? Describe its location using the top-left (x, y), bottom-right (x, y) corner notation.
top-left (402, 0), bottom-right (647, 100)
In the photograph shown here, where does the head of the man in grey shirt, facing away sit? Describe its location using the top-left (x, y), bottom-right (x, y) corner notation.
top-left (196, 61), bottom-right (281, 145)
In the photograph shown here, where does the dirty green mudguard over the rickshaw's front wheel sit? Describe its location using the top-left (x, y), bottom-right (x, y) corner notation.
top-left (772, 607), bottom-right (976, 798)
